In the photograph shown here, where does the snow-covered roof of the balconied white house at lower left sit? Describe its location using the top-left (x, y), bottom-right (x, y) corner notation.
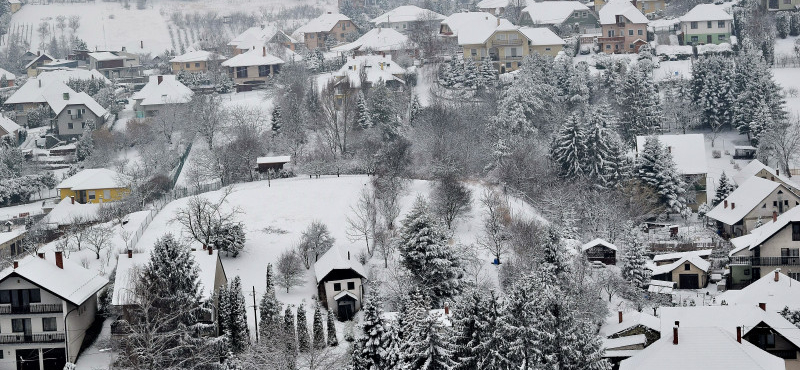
top-left (0, 252), bottom-right (108, 305)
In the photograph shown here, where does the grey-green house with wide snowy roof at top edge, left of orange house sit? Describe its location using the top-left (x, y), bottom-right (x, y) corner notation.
top-left (519, 1), bottom-right (599, 34)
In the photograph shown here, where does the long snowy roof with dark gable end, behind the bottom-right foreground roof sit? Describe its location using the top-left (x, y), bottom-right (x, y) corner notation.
top-left (659, 304), bottom-right (800, 347)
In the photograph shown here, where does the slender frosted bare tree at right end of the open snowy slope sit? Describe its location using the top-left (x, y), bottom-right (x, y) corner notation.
top-left (478, 189), bottom-right (511, 263)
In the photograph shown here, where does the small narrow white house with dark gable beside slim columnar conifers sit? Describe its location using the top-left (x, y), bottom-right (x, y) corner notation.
top-left (314, 246), bottom-right (366, 321)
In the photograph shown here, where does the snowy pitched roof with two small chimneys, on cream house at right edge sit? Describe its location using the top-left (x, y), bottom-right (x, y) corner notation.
top-left (706, 176), bottom-right (789, 225)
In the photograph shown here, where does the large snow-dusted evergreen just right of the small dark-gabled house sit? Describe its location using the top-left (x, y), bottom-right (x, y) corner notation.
top-left (399, 198), bottom-right (462, 304)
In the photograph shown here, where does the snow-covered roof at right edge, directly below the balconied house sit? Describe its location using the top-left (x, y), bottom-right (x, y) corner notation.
top-left (716, 269), bottom-right (800, 311)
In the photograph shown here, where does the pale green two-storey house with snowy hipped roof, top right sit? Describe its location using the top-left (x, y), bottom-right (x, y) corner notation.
top-left (681, 4), bottom-right (733, 45)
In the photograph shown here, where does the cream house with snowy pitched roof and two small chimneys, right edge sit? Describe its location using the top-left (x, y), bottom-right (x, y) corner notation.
top-left (706, 176), bottom-right (800, 236)
